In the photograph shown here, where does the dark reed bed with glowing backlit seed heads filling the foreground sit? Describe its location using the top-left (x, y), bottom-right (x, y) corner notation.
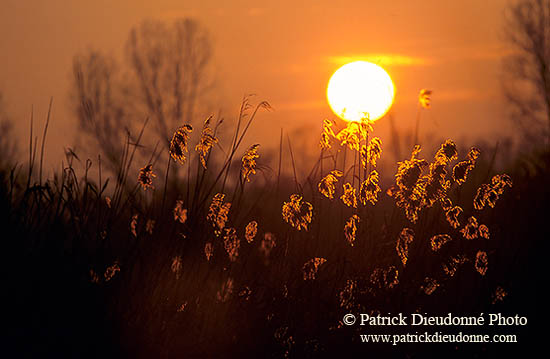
top-left (0, 103), bottom-right (550, 358)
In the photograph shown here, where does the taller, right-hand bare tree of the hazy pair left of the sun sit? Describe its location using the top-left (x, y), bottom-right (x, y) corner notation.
top-left (126, 19), bottom-right (211, 146)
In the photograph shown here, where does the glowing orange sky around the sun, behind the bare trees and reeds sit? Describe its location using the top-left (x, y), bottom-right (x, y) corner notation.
top-left (0, 0), bottom-right (511, 169)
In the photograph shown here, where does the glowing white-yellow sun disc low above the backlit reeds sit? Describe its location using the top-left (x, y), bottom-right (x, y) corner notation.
top-left (327, 61), bottom-right (395, 121)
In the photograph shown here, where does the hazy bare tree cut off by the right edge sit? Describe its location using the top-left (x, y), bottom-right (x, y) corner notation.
top-left (504, 0), bottom-right (550, 148)
